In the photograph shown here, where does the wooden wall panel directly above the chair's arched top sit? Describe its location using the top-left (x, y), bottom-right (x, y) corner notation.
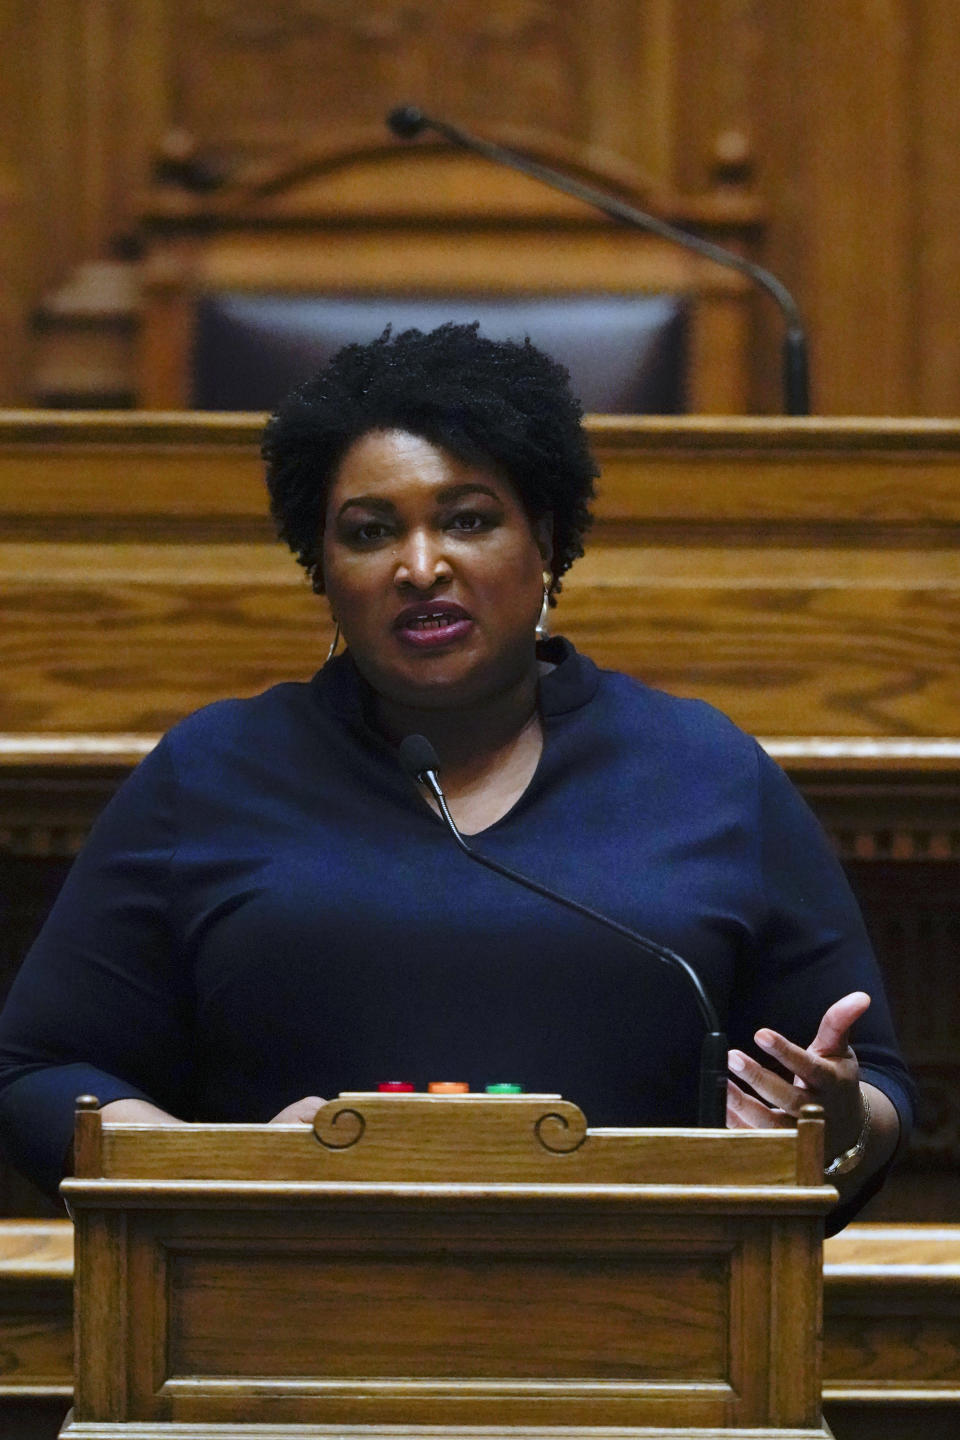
top-left (166, 0), bottom-right (671, 180)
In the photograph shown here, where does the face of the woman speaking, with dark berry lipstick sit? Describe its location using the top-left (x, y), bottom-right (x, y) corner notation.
top-left (322, 431), bottom-right (550, 708)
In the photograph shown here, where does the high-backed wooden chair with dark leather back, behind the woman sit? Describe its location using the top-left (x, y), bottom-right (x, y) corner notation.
top-left (140, 128), bottom-right (757, 413)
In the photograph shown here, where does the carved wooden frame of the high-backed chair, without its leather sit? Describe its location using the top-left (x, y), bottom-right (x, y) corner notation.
top-left (140, 130), bottom-right (759, 413)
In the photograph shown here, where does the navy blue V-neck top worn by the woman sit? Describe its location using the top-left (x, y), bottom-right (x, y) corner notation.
top-left (0, 641), bottom-right (911, 1215)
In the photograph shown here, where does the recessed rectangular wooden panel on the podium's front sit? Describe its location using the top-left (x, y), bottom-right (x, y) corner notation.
top-left (168, 1241), bottom-right (728, 1384)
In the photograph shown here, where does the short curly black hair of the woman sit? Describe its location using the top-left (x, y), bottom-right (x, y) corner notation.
top-left (262, 323), bottom-right (597, 599)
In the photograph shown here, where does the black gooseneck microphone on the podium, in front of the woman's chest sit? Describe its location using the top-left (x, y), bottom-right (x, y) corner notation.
top-left (399, 734), bottom-right (727, 1130)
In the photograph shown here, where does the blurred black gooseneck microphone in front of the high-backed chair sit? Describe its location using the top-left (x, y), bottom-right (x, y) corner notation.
top-left (387, 105), bottom-right (810, 415)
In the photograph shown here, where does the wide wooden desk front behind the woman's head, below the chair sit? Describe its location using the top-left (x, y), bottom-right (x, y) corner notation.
top-left (0, 415), bottom-right (960, 740)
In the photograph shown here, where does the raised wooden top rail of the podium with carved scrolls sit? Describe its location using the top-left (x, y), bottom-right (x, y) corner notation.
top-left (77, 1093), bottom-right (811, 1207)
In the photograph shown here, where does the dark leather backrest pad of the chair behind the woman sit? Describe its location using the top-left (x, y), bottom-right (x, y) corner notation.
top-left (190, 292), bottom-right (688, 415)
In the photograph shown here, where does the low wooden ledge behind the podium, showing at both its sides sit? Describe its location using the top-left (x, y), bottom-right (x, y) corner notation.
top-left (7, 1220), bottom-right (960, 1440)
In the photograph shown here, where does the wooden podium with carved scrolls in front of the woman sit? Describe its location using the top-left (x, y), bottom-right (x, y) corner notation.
top-left (62, 1093), bottom-right (836, 1440)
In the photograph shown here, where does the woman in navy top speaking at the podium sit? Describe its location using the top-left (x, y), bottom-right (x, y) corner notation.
top-left (0, 325), bottom-right (910, 1221)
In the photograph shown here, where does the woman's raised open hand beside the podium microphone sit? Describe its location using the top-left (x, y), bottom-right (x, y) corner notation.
top-left (727, 991), bottom-right (869, 1159)
